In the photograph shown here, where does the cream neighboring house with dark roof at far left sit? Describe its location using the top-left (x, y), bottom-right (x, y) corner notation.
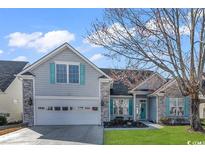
top-left (0, 61), bottom-right (28, 122)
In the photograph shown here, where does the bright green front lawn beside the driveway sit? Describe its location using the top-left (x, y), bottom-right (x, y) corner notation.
top-left (104, 126), bottom-right (205, 145)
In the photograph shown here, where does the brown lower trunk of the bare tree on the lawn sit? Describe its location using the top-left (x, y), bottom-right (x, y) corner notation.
top-left (190, 94), bottom-right (203, 131)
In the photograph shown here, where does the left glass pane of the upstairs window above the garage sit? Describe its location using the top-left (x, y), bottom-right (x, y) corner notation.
top-left (56, 64), bottom-right (67, 83)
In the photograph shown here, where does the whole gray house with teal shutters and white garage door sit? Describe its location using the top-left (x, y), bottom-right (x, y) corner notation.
top-left (18, 43), bottom-right (203, 125)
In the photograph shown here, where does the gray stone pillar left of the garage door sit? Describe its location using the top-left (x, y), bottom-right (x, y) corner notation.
top-left (23, 79), bottom-right (34, 126)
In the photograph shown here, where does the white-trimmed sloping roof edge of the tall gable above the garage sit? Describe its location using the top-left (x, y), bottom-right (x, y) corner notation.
top-left (19, 42), bottom-right (111, 80)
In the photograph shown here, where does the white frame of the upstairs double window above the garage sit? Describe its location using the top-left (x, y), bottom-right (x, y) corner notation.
top-left (55, 61), bottom-right (80, 85)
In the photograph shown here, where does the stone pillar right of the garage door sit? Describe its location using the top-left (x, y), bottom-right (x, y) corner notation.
top-left (100, 82), bottom-right (110, 124)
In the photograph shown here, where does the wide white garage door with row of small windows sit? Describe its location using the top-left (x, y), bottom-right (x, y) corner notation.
top-left (35, 99), bottom-right (101, 125)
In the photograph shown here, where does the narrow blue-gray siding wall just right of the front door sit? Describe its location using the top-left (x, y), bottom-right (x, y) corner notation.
top-left (148, 97), bottom-right (157, 122)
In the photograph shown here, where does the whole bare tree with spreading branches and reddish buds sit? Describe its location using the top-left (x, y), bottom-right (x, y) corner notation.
top-left (87, 9), bottom-right (205, 131)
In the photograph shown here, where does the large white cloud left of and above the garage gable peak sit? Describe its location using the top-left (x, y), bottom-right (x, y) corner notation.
top-left (7, 30), bottom-right (75, 52)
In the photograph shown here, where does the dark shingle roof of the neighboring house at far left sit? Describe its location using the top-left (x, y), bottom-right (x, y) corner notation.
top-left (0, 60), bottom-right (28, 92)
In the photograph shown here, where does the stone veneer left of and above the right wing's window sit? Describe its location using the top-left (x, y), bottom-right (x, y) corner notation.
top-left (158, 84), bottom-right (184, 123)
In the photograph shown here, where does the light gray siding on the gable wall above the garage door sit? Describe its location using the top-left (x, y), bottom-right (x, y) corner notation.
top-left (32, 48), bottom-right (102, 97)
